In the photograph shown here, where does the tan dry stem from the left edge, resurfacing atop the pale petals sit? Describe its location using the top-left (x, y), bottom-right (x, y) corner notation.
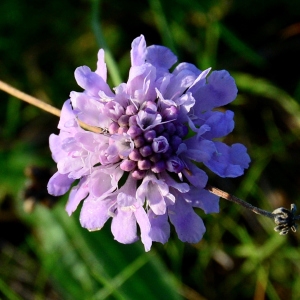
top-left (0, 80), bottom-right (103, 133)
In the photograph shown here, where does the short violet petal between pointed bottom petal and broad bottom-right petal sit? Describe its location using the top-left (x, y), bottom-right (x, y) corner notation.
top-left (148, 209), bottom-right (170, 244)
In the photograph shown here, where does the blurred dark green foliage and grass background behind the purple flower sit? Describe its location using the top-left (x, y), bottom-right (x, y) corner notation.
top-left (0, 0), bottom-right (300, 300)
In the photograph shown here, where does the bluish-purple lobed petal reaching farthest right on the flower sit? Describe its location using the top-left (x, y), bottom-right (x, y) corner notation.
top-left (204, 142), bottom-right (250, 177)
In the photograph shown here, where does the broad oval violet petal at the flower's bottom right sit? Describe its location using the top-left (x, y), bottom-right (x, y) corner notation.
top-left (168, 193), bottom-right (205, 243)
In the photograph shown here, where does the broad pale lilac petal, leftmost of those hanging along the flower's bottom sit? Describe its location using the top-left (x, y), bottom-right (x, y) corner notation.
top-left (79, 198), bottom-right (111, 231)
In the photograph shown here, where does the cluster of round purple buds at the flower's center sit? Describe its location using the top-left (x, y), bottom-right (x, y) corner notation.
top-left (109, 101), bottom-right (188, 179)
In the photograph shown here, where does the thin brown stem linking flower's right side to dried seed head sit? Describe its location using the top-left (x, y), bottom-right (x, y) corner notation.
top-left (205, 185), bottom-right (276, 219)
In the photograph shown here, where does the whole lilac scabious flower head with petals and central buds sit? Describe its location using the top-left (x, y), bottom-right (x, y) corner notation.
top-left (48, 36), bottom-right (250, 251)
